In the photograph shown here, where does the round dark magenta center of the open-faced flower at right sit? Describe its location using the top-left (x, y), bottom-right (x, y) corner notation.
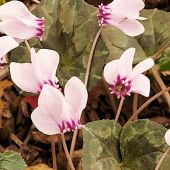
top-left (109, 75), bottom-right (131, 98)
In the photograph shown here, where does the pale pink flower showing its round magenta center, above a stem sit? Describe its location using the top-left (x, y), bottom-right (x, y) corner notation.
top-left (104, 48), bottom-right (154, 98)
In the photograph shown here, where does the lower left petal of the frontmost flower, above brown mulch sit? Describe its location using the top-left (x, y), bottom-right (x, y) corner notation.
top-left (31, 107), bottom-right (60, 135)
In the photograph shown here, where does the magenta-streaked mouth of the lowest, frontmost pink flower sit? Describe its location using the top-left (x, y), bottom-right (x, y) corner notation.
top-left (58, 120), bottom-right (83, 133)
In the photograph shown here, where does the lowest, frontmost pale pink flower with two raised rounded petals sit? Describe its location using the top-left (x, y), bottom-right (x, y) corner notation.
top-left (31, 77), bottom-right (88, 135)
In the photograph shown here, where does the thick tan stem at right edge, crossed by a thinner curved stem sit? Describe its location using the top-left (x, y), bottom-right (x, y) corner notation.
top-left (151, 65), bottom-right (170, 108)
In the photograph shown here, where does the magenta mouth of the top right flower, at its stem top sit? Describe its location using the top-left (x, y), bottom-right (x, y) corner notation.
top-left (98, 4), bottom-right (110, 26)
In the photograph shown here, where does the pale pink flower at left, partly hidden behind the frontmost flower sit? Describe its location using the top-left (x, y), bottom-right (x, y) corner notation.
top-left (10, 48), bottom-right (59, 93)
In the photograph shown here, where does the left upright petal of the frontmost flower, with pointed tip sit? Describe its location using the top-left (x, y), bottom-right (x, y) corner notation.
top-left (38, 84), bottom-right (64, 124)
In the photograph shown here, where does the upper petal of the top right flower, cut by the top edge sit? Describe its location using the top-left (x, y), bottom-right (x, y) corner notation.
top-left (112, 0), bottom-right (145, 19)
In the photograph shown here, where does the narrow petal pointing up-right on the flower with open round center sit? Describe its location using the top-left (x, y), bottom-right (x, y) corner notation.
top-left (129, 58), bottom-right (154, 80)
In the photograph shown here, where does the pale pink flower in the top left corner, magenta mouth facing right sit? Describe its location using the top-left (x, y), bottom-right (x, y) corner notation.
top-left (0, 1), bottom-right (44, 40)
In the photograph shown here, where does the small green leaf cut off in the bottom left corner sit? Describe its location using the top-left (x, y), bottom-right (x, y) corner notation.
top-left (0, 151), bottom-right (27, 170)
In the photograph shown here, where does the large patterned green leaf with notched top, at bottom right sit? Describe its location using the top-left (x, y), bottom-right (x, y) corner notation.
top-left (82, 120), bottom-right (170, 170)
